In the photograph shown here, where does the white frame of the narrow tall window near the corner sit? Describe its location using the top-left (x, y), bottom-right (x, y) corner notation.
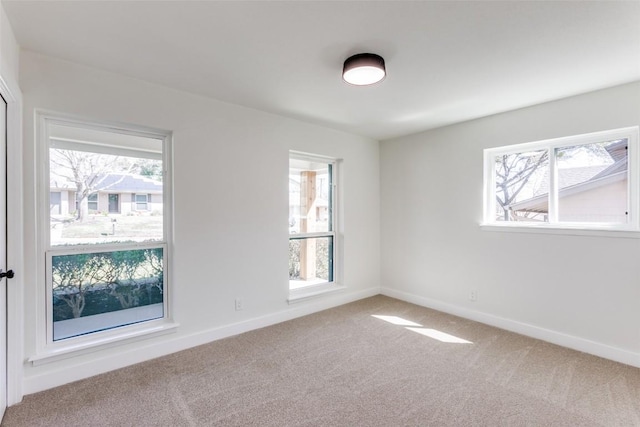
top-left (287, 150), bottom-right (344, 304)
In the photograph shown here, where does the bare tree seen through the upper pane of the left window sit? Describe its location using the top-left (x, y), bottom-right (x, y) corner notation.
top-left (49, 149), bottom-right (134, 222)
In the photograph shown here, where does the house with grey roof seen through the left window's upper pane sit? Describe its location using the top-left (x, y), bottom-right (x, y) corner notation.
top-left (49, 174), bottom-right (163, 216)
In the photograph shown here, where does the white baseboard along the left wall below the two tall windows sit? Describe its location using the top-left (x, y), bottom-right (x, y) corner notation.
top-left (21, 287), bottom-right (380, 396)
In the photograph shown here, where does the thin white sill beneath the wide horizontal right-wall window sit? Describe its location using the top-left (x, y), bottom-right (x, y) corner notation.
top-left (480, 223), bottom-right (640, 239)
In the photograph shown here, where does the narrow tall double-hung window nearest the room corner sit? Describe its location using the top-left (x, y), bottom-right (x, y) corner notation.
top-left (289, 153), bottom-right (336, 290)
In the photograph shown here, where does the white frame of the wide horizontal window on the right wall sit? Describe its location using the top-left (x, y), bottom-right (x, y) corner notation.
top-left (481, 126), bottom-right (640, 237)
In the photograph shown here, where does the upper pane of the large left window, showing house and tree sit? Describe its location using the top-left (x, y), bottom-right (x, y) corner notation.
top-left (49, 134), bottom-right (164, 246)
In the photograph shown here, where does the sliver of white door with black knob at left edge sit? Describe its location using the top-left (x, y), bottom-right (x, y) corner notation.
top-left (0, 96), bottom-right (7, 419)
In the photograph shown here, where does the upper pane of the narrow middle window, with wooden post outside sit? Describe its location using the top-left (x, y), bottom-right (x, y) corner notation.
top-left (289, 159), bottom-right (333, 234)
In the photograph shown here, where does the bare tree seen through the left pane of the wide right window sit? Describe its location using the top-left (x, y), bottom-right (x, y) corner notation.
top-left (496, 150), bottom-right (549, 221)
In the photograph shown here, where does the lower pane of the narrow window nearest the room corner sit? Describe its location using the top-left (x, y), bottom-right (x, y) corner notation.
top-left (289, 237), bottom-right (333, 289)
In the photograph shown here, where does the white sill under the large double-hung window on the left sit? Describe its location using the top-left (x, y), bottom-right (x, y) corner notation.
top-left (27, 320), bottom-right (179, 366)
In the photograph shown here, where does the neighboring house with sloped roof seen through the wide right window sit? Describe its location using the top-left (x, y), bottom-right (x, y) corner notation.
top-left (509, 140), bottom-right (628, 223)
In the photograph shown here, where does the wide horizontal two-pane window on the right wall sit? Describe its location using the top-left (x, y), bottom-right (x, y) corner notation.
top-left (484, 127), bottom-right (639, 230)
